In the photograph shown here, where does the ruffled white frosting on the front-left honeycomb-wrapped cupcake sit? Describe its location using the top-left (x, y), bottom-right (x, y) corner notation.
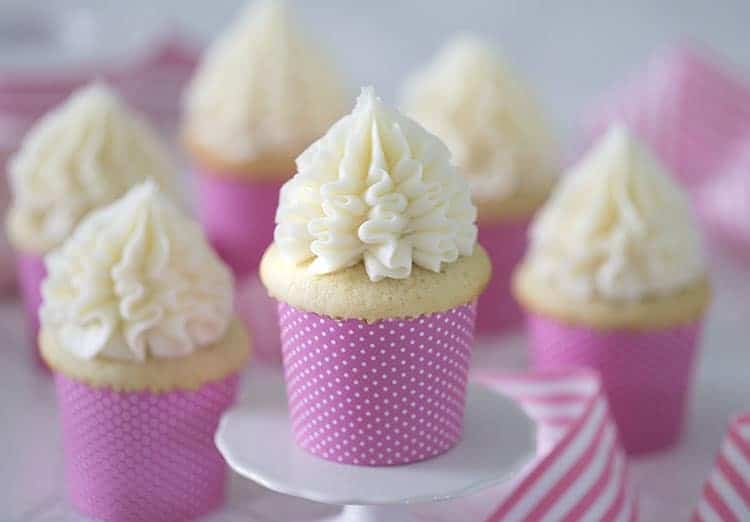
top-left (40, 182), bottom-right (233, 361)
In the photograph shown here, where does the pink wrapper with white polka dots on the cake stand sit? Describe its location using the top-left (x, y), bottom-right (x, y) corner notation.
top-left (279, 303), bottom-right (476, 466)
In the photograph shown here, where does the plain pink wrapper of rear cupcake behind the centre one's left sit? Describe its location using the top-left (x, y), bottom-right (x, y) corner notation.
top-left (196, 171), bottom-right (282, 279)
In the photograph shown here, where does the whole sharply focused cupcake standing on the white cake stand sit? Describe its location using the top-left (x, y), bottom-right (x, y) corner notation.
top-left (260, 88), bottom-right (491, 466)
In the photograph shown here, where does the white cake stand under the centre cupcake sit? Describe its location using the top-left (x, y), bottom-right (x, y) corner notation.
top-left (216, 378), bottom-right (536, 522)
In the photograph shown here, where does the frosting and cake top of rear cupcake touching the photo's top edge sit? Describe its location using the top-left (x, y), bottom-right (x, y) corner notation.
top-left (184, 0), bottom-right (347, 178)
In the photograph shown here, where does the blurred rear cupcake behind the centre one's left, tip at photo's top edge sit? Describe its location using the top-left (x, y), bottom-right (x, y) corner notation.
top-left (182, 0), bottom-right (347, 279)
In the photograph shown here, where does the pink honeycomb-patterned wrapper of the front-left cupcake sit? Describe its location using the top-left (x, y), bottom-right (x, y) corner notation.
top-left (55, 373), bottom-right (238, 522)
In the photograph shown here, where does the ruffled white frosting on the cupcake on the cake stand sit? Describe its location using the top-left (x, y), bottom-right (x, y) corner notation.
top-left (275, 88), bottom-right (477, 281)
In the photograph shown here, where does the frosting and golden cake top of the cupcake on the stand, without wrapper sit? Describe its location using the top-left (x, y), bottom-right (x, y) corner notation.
top-left (261, 88), bottom-right (489, 320)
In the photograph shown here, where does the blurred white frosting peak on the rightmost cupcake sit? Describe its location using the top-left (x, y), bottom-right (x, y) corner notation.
top-left (526, 123), bottom-right (706, 300)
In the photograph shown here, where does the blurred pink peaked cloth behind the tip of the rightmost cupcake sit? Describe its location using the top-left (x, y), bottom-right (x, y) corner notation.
top-left (584, 47), bottom-right (750, 188)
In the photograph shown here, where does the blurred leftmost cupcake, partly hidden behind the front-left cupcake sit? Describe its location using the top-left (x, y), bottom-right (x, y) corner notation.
top-left (6, 84), bottom-right (175, 364)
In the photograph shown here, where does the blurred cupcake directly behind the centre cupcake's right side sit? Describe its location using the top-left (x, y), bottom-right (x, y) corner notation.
top-left (402, 36), bottom-right (557, 334)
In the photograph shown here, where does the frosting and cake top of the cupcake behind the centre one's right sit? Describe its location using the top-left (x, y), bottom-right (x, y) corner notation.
top-left (403, 36), bottom-right (557, 219)
